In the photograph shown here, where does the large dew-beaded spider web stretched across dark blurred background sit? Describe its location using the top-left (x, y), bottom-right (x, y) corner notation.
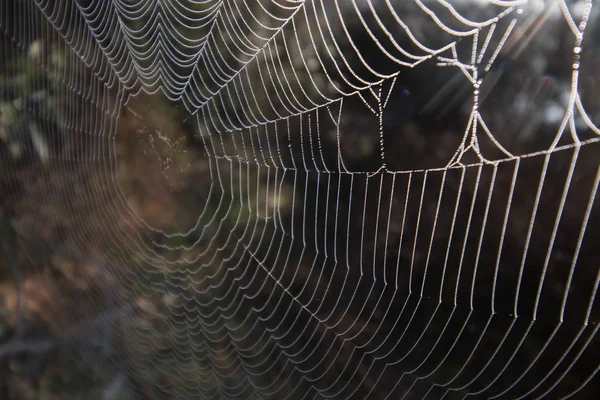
top-left (0, 0), bottom-right (600, 399)
